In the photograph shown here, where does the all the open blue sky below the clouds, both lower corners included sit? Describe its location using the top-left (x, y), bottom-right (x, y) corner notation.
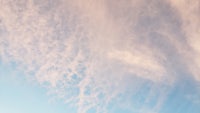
top-left (0, 62), bottom-right (200, 113)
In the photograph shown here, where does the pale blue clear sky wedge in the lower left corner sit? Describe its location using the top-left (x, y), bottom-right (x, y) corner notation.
top-left (0, 62), bottom-right (76, 113)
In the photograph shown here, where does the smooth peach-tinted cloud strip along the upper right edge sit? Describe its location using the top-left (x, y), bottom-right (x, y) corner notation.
top-left (170, 0), bottom-right (200, 81)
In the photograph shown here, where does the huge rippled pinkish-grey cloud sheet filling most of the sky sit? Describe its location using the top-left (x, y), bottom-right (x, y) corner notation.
top-left (0, 0), bottom-right (200, 113)
